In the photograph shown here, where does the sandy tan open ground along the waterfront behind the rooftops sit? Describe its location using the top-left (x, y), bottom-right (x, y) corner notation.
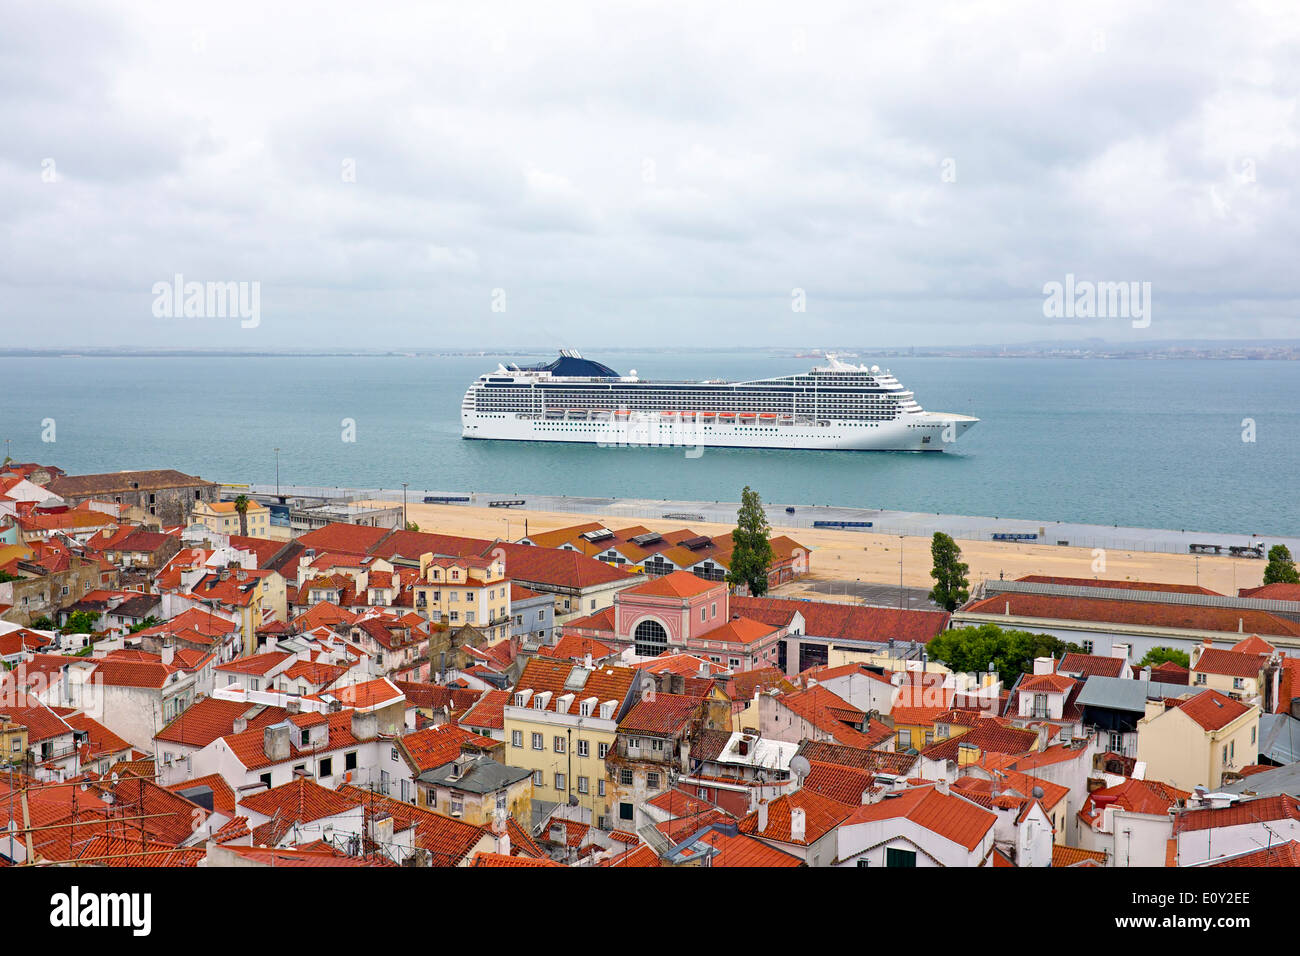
top-left (369, 502), bottom-right (1265, 600)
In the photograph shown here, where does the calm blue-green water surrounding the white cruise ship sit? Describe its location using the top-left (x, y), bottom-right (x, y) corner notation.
top-left (0, 352), bottom-right (1300, 535)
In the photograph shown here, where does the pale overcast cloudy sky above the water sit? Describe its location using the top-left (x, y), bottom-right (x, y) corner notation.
top-left (0, 0), bottom-right (1300, 351)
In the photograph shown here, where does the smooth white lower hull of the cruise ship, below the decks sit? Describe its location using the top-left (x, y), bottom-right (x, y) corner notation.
top-left (460, 411), bottom-right (979, 451)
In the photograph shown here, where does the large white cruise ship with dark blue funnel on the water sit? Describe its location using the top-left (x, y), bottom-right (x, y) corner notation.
top-left (460, 350), bottom-right (979, 451)
